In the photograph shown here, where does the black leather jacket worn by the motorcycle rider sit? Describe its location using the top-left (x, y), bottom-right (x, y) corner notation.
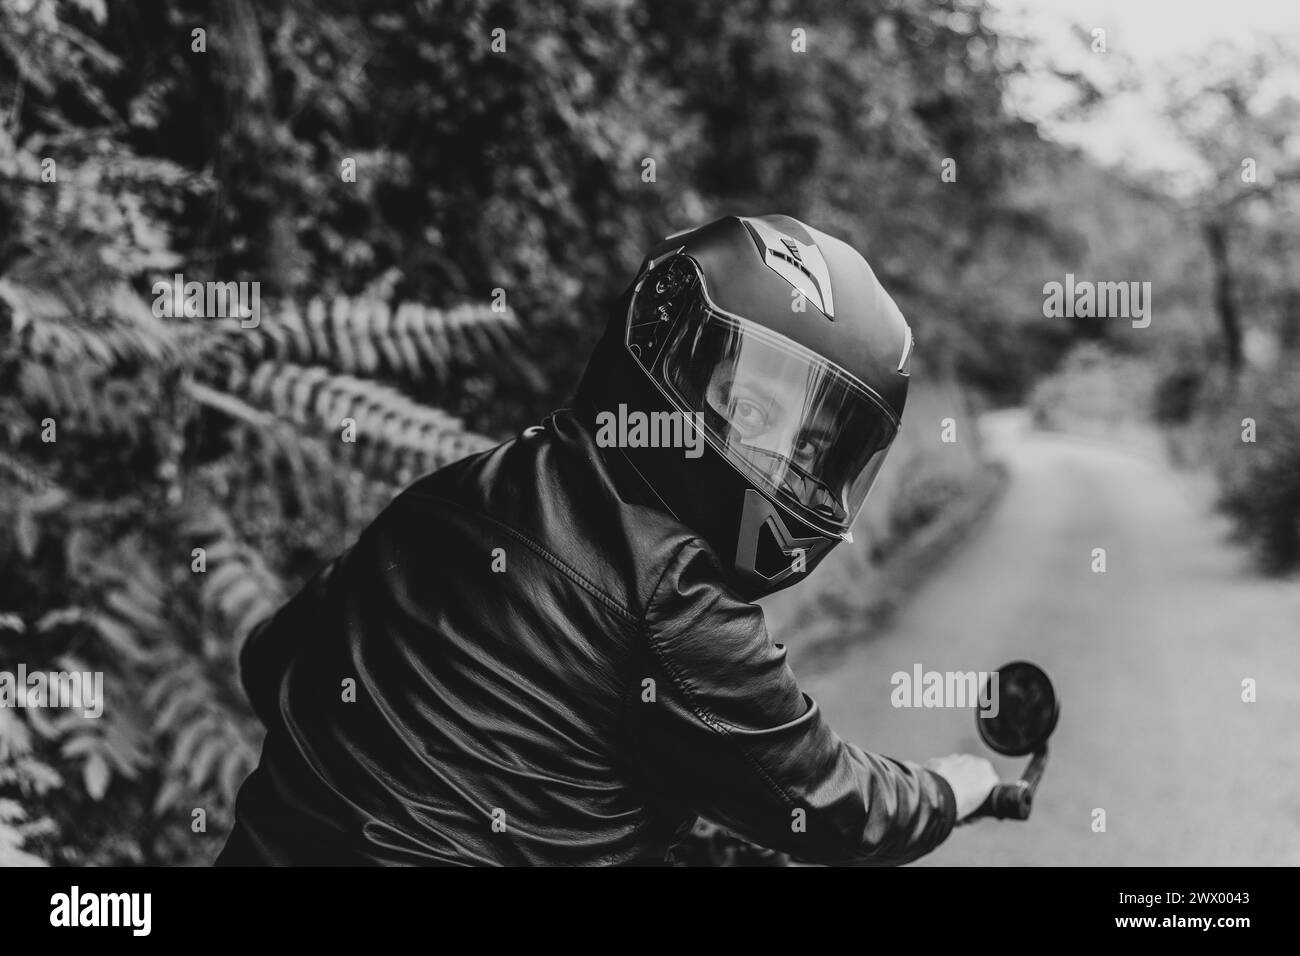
top-left (217, 410), bottom-right (956, 865)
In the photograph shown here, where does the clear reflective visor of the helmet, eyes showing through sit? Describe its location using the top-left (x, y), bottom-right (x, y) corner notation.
top-left (629, 257), bottom-right (898, 535)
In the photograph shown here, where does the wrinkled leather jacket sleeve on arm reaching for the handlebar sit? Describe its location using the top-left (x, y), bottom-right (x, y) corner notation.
top-left (628, 541), bottom-right (957, 865)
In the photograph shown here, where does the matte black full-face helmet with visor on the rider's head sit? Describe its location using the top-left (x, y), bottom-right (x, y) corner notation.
top-left (576, 216), bottom-right (913, 600)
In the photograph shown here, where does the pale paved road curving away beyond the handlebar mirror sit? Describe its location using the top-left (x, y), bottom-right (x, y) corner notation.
top-left (789, 415), bottom-right (1300, 868)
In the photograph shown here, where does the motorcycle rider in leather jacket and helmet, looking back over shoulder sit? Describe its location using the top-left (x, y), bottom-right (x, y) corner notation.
top-left (218, 216), bottom-right (996, 865)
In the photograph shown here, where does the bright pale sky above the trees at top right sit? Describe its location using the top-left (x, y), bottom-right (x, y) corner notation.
top-left (991, 0), bottom-right (1300, 173)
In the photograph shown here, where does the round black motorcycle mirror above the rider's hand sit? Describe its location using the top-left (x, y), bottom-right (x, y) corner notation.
top-left (975, 661), bottom-right (1061, 757)
